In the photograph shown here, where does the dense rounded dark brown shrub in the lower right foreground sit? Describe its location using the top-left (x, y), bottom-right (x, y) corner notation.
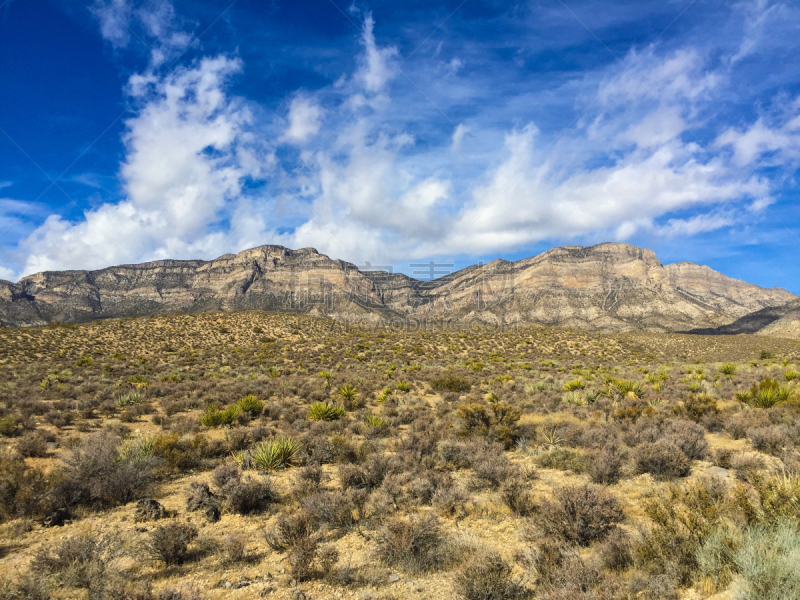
top-left (536, 485), bottom-right (623, 546)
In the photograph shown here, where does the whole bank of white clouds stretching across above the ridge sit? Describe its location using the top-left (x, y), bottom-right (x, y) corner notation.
top-left (7, 1), bottom-right (800, 273)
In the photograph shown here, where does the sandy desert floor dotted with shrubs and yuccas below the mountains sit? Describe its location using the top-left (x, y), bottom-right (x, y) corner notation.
top-left (0, 312), bottom-right (800, 600)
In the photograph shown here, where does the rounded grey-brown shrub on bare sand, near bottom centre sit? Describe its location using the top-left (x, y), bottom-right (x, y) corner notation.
top-left (377, 515), bottom-right (445, 573)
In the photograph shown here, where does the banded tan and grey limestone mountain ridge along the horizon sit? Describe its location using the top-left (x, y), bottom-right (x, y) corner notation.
top-left (0, 244), bottom-right (797, 331)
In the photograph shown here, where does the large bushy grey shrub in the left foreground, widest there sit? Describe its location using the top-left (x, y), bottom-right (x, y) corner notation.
top-left (54, 432), bottom-right (159, 506)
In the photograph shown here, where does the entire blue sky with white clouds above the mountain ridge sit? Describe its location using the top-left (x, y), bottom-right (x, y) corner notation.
top-left (0, 0), bottom-right (800, 294)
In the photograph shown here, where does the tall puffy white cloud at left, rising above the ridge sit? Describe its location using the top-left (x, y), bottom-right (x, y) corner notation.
top-left (22, 57), bottom-right (271, 273)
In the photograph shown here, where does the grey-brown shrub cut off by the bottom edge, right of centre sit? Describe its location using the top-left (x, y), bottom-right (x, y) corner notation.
top-left (454, 552), bottom-right (530, 600)
